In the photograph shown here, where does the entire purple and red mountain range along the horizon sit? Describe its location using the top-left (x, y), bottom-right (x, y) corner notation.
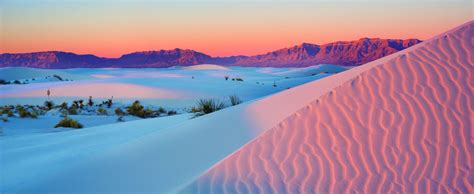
top-left (0, 38), bottom-right (421, 68)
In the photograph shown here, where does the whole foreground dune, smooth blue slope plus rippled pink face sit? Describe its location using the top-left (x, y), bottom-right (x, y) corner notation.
top-left (0, 22), bottom-right (474, 193)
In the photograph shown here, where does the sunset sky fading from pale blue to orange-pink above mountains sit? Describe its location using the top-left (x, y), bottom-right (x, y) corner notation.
top-left (0, 0), bottom-right (473, 57)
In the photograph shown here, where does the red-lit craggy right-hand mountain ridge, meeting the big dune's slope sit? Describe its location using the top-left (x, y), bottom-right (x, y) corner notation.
top-left (232, 38), bottom-right (421, 67)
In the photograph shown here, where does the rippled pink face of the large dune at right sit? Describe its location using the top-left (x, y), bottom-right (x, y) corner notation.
top-left (182, 21), bottom-right (474, 193)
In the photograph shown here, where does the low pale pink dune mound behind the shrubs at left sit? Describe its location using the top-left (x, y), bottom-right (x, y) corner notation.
top-left (0, 83), bottom-right (184, 98)
